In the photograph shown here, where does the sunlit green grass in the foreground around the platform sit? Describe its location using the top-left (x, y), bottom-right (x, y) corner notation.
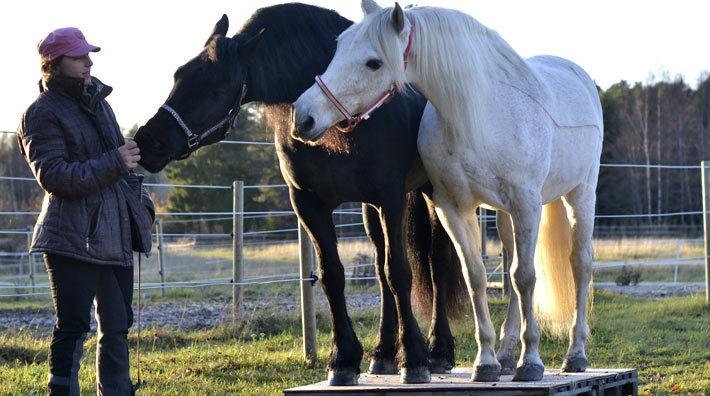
top-left (0, 292), bottom-right (710, 395)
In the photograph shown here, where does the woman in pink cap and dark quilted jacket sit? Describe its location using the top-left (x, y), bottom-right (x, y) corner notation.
top-left (17, 28), bottom-right (154, 395)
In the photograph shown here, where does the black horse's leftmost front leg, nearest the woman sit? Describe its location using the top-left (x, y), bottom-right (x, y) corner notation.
top-left (289, 188), bottom-right (362, 385)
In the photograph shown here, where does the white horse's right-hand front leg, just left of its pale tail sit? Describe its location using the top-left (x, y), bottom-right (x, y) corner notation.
top-left (510, 189), bottom-right (545, 381)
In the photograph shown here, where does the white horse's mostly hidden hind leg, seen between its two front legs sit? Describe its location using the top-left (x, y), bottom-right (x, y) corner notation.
top-left (496, 210), bottom-right (520, 375)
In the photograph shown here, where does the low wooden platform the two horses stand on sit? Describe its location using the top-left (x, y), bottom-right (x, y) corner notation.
top-left (284, 368), bottom-right (638, 396)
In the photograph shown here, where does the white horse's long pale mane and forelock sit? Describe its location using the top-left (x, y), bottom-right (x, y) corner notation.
top-left (368, 7), bottom-right (539, 141)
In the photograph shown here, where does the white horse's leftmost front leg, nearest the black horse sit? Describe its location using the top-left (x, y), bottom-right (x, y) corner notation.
top-left (434, 191), bottom-right (501, 382)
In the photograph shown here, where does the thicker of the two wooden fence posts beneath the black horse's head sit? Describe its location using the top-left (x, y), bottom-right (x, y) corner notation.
top-left (232, 180), bottom-right (244, 325)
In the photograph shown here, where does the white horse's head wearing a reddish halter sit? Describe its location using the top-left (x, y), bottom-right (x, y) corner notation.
top-left (294, 0), bottom-right (412, 141)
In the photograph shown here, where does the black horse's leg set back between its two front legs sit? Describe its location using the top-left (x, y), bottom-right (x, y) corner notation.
top-left (362, 204), bottom-right (398, 374)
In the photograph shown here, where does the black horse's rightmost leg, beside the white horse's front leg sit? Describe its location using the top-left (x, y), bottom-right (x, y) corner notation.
top-left (427, 190), bottom-right (456, 373)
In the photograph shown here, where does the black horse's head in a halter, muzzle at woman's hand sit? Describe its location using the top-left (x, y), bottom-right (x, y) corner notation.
top-left (135, 15), bottom-right (257, 172)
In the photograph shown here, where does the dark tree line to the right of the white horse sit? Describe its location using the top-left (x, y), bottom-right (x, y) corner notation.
top-left (597, 76), bottom-right (710, 234)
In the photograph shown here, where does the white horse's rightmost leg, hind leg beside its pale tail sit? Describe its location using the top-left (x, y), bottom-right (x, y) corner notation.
top-left (562, 183), bottom-right (596, 372)
